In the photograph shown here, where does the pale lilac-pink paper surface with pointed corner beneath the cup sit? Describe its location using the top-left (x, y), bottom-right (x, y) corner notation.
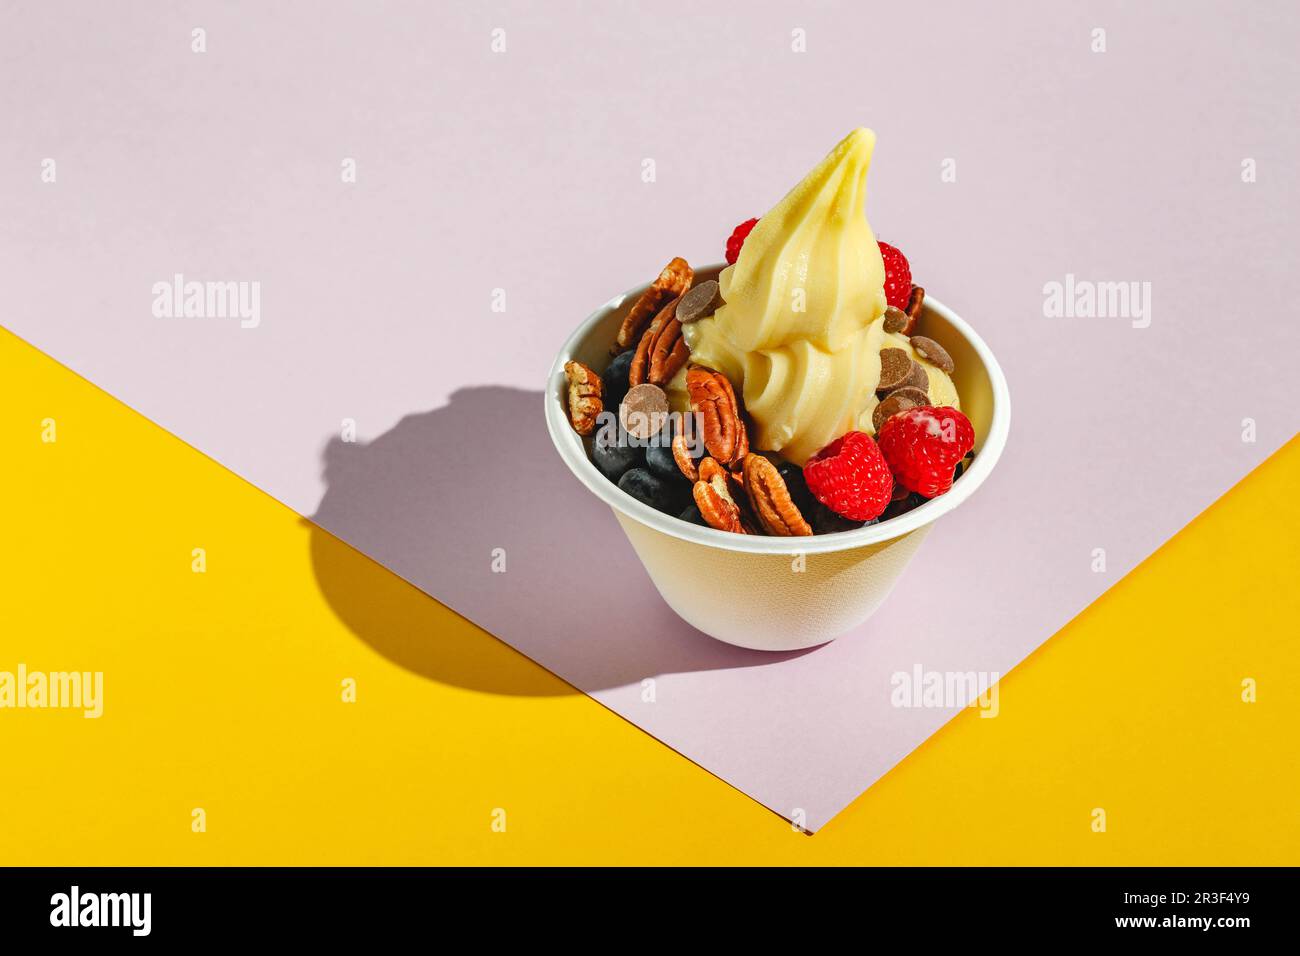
top-left (0, 3), bottom-right (1300, 829)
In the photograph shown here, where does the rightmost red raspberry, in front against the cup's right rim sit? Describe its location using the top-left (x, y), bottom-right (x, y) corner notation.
top-left (876, 405), bottom-right (975, 498)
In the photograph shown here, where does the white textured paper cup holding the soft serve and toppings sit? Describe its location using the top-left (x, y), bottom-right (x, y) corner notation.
top-left (546, 265), bottom-right (1011, 650)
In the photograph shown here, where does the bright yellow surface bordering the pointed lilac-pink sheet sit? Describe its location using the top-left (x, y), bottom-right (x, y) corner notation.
top-left (0, 332), bottom-right (1300, 865)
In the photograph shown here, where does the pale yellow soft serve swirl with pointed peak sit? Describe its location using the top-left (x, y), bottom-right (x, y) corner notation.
top-left (683, 129), bottom-right (957, 466)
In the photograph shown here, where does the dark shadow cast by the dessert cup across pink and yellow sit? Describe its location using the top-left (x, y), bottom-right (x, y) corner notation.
top-left (311, 385), bottom-right (809, 696)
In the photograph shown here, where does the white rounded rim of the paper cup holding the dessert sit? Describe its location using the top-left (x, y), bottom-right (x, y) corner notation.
top-left (545, 263), bottom-right (1011, 555)
